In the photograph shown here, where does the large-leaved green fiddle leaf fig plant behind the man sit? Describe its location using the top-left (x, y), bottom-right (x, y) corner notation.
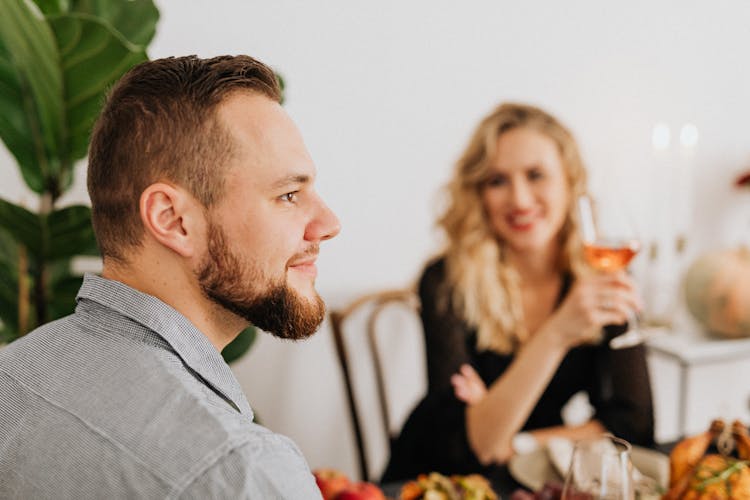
top-left (0, 0), bottom-right (159, 343)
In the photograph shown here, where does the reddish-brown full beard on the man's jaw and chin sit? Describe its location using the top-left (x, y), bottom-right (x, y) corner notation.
top-left (196, 219), bottom-right (325, 340)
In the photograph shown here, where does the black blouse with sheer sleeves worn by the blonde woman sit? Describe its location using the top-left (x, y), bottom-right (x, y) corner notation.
top-left (383, 259), bottom-right (654, 481)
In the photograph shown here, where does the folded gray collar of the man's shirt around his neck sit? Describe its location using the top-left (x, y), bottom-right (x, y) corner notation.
top-left (76, 273), bottom-right (253, 419)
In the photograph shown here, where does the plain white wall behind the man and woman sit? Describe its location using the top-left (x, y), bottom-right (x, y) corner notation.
top-left (0, 0), bottom-right (750, 478)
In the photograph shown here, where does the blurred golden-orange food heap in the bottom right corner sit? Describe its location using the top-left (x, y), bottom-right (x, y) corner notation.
top-left (663, 420), bottom-right (750, 500)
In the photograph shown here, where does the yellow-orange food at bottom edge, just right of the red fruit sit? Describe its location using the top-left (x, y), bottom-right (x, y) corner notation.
top-left (399, 472), bottom-right (498, 500)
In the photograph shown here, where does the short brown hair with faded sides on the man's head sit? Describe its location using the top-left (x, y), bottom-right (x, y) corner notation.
top-left (88, 56), bottom-right (281, 262)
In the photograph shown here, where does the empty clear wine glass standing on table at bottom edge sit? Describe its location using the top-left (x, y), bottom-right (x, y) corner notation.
top-left (561, 434), bottom-right (635, 500)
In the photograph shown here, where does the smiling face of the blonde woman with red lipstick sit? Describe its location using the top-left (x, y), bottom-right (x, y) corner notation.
top-left (481, 127), bottom-right (570, 252)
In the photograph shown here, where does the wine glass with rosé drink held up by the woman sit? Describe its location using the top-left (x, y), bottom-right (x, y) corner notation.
top-left (578, 195), bottom-right (645, 349)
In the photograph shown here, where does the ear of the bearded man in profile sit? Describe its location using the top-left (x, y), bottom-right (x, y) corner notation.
top-left (139, 182), bottom-right (204, 258)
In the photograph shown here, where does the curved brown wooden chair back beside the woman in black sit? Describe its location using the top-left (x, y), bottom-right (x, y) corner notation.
top-left (329, 289), bottom-right (426, 481)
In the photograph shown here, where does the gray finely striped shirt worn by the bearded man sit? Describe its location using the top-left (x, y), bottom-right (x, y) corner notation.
top-left (0, 275), bottom-right (320, 499)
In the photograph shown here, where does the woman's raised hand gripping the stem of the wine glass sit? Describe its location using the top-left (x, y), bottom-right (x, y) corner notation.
top-left (544, 271), bottom-right (642, 348)
